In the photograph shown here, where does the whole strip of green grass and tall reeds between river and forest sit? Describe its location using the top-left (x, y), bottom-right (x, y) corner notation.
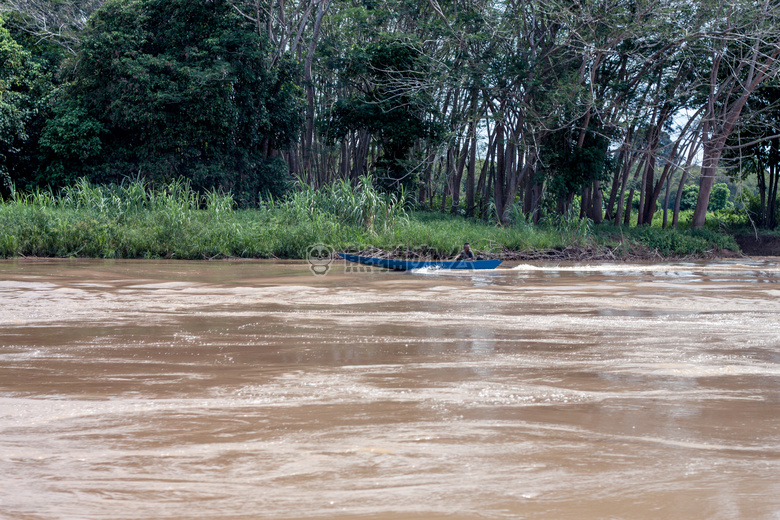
top-left (0, 177), bottom-right (738, 259)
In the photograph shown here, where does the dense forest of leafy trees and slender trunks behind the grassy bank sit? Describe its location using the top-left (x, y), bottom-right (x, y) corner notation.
top-left (0, 0), bottom-right (780, 228)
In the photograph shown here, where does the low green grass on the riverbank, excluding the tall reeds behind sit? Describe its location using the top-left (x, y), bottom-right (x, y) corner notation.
top-left (0, 206), bottom-right (744, 261)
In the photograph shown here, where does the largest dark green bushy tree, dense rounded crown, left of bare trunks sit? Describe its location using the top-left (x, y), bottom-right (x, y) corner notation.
top-left (42, 0), bottom-right (301, 203)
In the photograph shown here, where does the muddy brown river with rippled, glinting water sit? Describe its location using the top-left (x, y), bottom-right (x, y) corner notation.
top-left (0, 259), bottom-right (780, 520)
